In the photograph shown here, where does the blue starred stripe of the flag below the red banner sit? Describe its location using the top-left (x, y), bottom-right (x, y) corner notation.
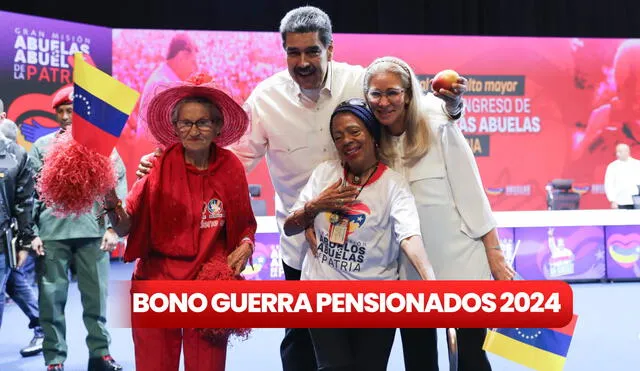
top-left (497, 328), bottom-right (571, 357)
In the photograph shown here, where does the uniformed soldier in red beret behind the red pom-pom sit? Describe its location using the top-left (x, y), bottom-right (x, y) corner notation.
top-left (29, 86), bottom-right (127, 371)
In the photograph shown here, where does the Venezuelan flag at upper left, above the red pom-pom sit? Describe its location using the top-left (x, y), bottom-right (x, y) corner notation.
top-left (71, 53), bottom-right (140, 156)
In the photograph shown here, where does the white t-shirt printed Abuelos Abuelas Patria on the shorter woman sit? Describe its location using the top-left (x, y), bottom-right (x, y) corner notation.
top-left (293, 160), bottom-right (421, 280)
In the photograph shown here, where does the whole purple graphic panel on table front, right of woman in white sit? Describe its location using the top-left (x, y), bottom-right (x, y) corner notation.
top-left (515, 227), bottom-right (605, 280)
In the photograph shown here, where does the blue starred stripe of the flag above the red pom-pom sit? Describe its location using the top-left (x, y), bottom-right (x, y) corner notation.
top-left (73, 84), bottom-right (129, 138)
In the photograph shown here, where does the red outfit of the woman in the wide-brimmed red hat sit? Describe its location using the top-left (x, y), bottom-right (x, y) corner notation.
top-left (125, 144), bottom-right (256, 371)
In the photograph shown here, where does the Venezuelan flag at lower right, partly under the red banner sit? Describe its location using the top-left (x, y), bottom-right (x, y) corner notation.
top-left (482, 314), bottom-right (578, 371)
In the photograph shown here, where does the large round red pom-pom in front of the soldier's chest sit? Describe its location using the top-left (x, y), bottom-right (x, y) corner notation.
top-left (36, 130), bottom-right (117, 217)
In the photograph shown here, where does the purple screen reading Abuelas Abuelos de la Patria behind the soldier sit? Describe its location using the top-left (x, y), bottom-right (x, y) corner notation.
top-left (0, 11), bottom-right (111, 150)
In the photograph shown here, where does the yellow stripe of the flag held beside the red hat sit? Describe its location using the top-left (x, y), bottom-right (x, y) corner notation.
top-left (73, 53), bottom-right (140, 115)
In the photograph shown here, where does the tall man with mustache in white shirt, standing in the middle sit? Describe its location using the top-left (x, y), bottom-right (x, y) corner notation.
top-left (230, 7), bottom-right (364, 371)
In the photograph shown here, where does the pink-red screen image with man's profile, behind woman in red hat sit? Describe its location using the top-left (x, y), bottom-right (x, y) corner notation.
top-left (113, 30), bottom-right (286, 208)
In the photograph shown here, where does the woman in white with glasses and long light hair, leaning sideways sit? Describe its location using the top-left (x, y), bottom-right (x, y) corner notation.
top-left (364, 57), bottom-right (514, 371)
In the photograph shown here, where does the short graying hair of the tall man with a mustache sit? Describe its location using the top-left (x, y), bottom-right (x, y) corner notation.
top-left (280, 6), bottom-right (333, 48)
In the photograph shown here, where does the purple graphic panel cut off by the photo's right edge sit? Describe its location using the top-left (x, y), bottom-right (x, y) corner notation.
top-left (605, 225), bottom-right (640, 279)
